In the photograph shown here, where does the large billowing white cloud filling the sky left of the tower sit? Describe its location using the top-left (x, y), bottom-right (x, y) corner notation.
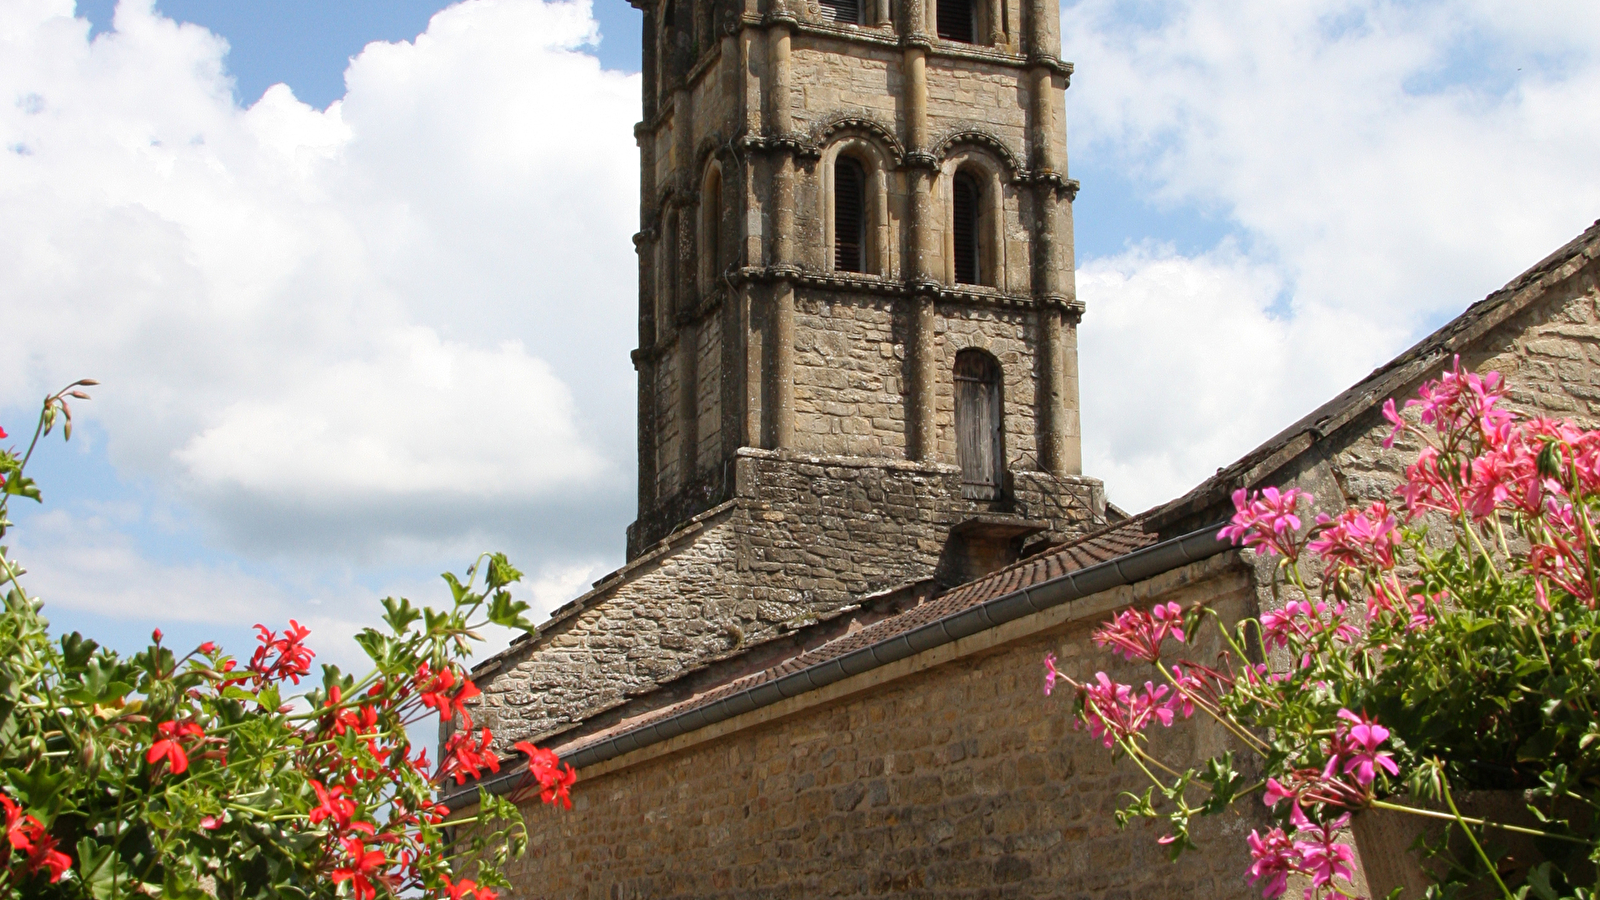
top-left (0, 0), bottom-right (638, 554)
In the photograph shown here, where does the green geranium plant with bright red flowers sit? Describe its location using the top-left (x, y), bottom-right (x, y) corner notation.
top-left (0, 381), bottom-right (574, 900)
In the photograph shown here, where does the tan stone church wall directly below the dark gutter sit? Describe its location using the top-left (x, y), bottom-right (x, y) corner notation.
top-left (509, 554), bottom-right (1262, 900)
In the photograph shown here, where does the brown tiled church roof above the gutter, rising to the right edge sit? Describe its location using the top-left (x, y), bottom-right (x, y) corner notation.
top-left (444, 221), bottom-right (1600, 807)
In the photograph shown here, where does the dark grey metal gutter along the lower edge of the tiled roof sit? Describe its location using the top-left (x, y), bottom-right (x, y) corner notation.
top-left (445, 524), bottom-right (1234, 810)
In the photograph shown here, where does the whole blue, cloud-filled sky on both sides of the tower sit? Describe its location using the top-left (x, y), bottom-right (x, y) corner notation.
top-left (0, 0), bottom-right (1600, 661)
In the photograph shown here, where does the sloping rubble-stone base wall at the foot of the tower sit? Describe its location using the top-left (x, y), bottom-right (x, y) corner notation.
top-left (474, 450), bottom-right (1106, 745)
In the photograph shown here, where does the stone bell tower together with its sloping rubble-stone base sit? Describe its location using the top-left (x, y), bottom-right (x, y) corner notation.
top-left (475, 0), bottom-right (1106, 741)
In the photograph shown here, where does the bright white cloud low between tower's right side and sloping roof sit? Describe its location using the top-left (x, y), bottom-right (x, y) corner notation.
top-left (1078, 243), bottom-right (1403, 512)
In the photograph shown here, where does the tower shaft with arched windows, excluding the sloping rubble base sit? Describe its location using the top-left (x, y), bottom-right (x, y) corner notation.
top-left (629, 0), bottom-right (1083, 559)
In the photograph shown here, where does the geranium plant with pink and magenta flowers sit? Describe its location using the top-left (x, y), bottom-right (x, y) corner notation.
top-left (1046, 360), bottom-right (1600, 900)
